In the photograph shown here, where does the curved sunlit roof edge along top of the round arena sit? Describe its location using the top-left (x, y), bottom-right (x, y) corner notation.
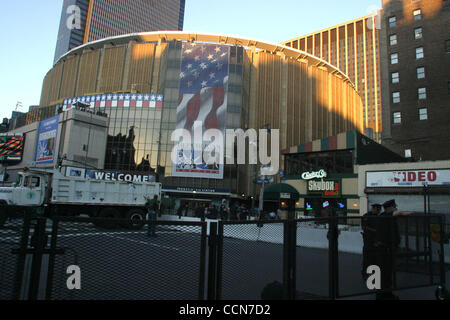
top-left (55, 31), bottom-right (355, 88)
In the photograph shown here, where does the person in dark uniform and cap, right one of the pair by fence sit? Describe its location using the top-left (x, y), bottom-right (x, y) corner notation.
top-left (375, 199), bottom-right (400, 300)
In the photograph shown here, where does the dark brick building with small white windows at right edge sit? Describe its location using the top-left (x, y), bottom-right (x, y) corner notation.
top-left (380, 0), bottom-right (450, 160)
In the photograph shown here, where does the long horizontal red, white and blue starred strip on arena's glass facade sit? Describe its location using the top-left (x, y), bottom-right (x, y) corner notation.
top-left (63, 93), bottom-right (164, 111)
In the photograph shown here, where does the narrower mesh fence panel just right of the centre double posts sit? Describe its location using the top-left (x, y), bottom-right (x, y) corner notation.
top-left (216, 220), bottom-right (285, 300)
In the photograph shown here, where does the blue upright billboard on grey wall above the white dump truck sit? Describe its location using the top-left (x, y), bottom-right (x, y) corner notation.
top-left (36, 115), bottom-right (59, 164)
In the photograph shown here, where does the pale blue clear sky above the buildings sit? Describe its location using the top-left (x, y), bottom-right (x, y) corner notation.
top-left (0, 0), bottom-right (381, 120)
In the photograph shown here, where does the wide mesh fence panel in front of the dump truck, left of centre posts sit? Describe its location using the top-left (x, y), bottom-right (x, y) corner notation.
top-left (44, 218), bottom-right (206, 300)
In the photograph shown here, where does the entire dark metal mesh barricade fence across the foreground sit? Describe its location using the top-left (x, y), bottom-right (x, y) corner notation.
top-left (0, 215), bottom-right (448, 300)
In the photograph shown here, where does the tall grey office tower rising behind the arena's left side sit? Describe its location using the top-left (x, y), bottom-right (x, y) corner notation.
top-left (54, 0), bottom-right (185, 62)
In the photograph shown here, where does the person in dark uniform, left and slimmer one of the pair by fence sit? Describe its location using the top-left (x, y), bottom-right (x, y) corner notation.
top-left (361, 203), bottom-right (382, 280)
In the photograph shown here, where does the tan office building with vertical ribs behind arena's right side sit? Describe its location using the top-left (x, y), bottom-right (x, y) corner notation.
top-left (282, 13), bottom-right (382, 141)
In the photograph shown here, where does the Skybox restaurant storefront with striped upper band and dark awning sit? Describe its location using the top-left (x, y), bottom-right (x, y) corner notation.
top-left (283, 131), bottom-right (405, 217)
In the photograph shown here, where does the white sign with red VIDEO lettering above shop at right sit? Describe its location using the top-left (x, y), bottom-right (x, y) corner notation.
top-left (366, 169), bottom-right (450, 187)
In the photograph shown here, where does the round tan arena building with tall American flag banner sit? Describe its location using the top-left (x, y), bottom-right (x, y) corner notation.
top-left (35, 32), bottom-right (363, 206)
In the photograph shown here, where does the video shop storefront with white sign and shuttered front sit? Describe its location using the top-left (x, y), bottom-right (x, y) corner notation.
top-left (359, 160), bottom-right (450, 215)
